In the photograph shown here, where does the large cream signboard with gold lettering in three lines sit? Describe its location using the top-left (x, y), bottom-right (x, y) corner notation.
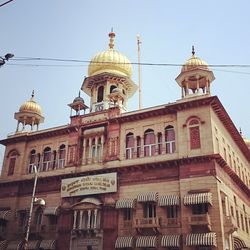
top-left (61, 173), bottom-right (117, 197)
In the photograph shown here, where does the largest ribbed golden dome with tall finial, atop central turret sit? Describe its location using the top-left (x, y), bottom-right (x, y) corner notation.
top-left (88, 32), bottom-right (132, 78)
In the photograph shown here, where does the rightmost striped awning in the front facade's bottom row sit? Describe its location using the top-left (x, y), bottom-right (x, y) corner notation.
top-left (186, 233), bottom-right (216, 246)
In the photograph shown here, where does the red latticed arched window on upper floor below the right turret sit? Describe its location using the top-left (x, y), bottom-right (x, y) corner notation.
top-left (188, 118), bottom-right (201, 149)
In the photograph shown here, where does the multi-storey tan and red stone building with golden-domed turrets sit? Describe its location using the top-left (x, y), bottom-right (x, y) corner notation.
top-left (0, 32), bottom-right (250, 250)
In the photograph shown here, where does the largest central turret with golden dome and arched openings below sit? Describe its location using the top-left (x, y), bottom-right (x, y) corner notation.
top-left (81, 29), bottom-right (137, 112)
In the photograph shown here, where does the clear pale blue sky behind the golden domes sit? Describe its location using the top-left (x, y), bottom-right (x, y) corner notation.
top-left (0, 0), bottom-right (250, 166)
